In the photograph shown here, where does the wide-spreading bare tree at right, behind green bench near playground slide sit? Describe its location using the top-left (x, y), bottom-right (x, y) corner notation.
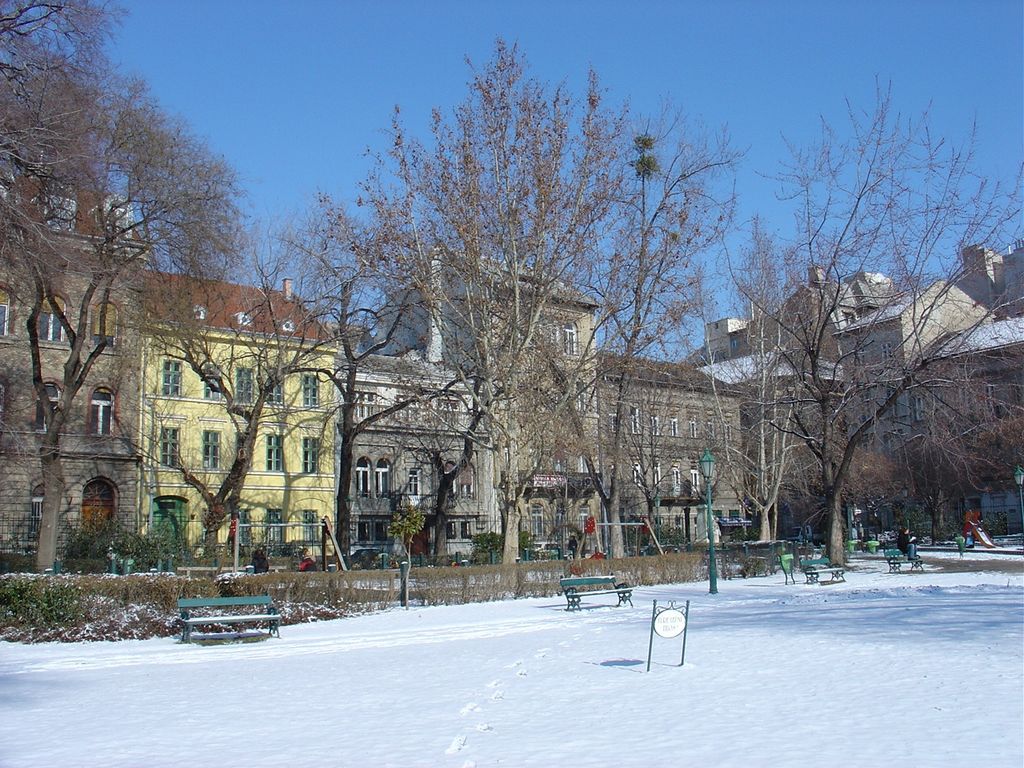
top-left (741, 93), bottom-right (1018, 560)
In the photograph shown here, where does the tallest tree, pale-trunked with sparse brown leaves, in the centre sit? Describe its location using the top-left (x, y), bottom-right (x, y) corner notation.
top-left (367, 41), bottom-right (617, 560)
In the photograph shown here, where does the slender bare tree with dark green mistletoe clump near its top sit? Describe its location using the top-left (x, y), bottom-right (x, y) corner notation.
top-left (586, 113), bottom-right (737, 557)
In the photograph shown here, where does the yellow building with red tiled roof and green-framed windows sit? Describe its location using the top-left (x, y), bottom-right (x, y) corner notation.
top-left (139, 275), bottom-right (335, 558)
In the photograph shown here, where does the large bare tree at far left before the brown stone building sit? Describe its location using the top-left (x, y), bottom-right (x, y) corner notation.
top-left (0, 7), bottom-right (237, 568)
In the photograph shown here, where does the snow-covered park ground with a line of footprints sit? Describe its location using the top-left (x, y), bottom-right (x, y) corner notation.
top-left (0, 552), bottom-right (1024, 768)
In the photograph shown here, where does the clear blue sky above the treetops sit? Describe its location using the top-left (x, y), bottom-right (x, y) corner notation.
top-left (110, 0), bottom-right (1024, 245)
